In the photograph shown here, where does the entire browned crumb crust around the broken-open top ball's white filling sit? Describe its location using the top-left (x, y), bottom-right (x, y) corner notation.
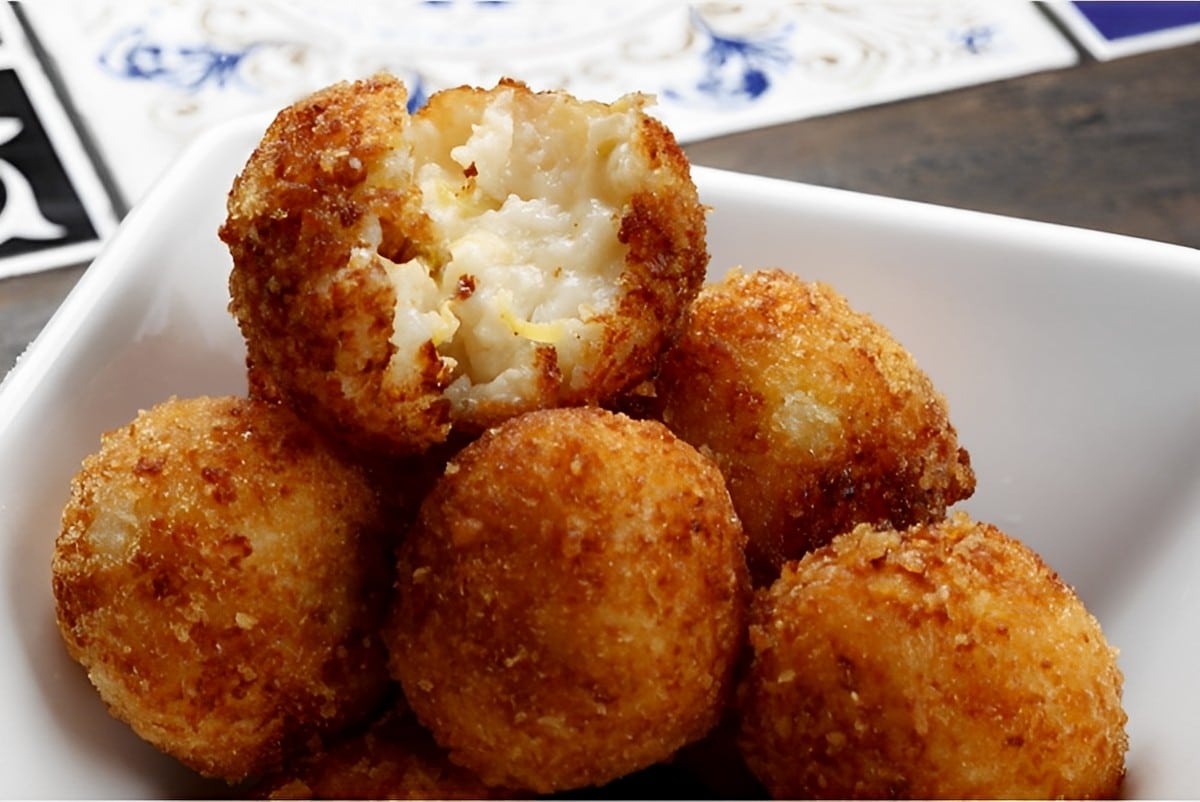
top-left (221, 74), bottom-right (708, 453)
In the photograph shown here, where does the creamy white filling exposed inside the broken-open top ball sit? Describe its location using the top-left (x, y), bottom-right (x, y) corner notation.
top-left (362, 88), bottom-right (646, 409)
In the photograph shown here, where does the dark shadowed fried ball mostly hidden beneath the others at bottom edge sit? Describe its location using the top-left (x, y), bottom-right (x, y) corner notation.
top-left (256, 704), bottom-right (515, 800)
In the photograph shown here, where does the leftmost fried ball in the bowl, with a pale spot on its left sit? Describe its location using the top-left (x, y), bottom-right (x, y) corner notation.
top-left (52, 397), bottom-right (391, 782)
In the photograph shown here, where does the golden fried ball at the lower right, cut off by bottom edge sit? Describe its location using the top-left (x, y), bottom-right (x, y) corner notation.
top-left (739, 513), bottom-right (1128, 798)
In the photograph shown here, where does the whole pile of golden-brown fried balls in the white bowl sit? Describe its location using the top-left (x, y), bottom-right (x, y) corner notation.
top-left (53, 74), bottom-right (1126, 797)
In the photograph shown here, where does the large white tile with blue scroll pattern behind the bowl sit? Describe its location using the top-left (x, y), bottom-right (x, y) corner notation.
top-left (29, 0), bottom-right (1076, 210)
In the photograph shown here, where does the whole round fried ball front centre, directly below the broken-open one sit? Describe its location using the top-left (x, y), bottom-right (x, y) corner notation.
top-left (385, 407), bottom-right (749, 792)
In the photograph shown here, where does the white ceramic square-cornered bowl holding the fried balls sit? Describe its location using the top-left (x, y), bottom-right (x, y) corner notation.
top-left (0, 112), bottom-right (1200, 798)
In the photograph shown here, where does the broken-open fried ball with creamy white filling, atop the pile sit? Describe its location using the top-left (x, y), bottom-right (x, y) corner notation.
top-left (220, 73), bottom-right (708, 453)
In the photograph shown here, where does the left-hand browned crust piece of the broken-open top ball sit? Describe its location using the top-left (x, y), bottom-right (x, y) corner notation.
top-left (220, 76), bottom-right (450, 450)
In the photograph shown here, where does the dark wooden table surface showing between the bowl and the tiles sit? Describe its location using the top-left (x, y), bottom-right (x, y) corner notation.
top-left (0, 44), bottom-right (1200, 376)
